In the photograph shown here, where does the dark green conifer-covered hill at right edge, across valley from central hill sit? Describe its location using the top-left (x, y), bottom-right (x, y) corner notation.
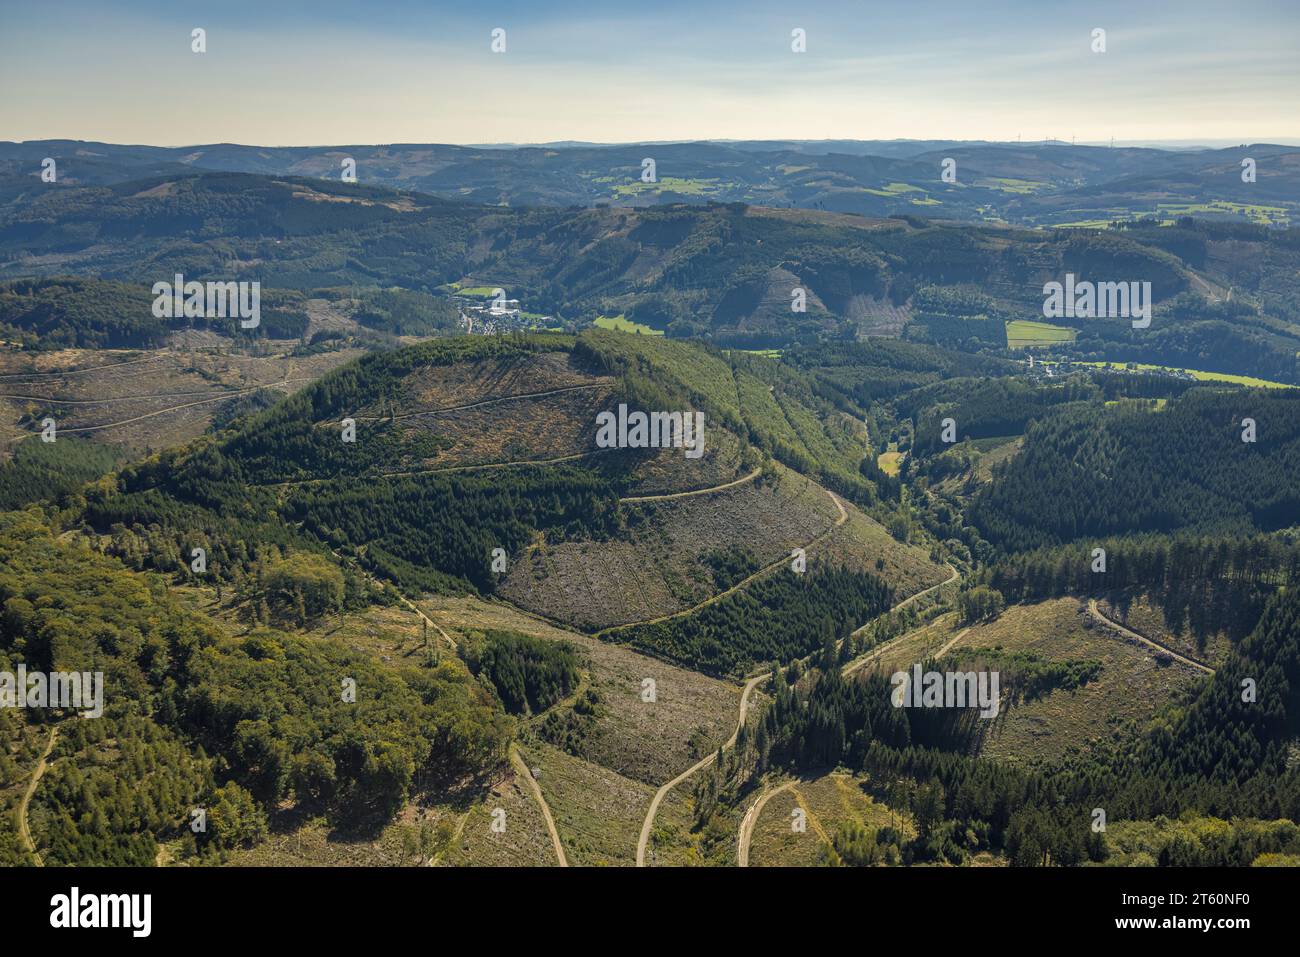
top-left (970, 389), bottom-right (1300, 550)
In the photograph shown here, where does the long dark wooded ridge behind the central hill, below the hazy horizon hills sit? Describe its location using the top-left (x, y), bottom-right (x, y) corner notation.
top-left (0, 166), bottom-right (1300, 381)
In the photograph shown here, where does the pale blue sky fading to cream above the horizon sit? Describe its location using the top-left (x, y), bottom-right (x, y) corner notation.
top-left (0, 0), bottom-right (1300, 146)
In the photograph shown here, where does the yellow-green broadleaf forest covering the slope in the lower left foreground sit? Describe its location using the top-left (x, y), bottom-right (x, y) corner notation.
top-left (0, 510), bottom-right (511, 866)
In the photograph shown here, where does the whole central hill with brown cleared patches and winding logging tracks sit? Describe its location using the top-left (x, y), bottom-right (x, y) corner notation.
top-left (30, 330), bottom-right (948, 674)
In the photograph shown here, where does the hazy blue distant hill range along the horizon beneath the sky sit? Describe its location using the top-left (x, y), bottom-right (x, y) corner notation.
top-left (0, 140), bottom-right (1300, 226)
